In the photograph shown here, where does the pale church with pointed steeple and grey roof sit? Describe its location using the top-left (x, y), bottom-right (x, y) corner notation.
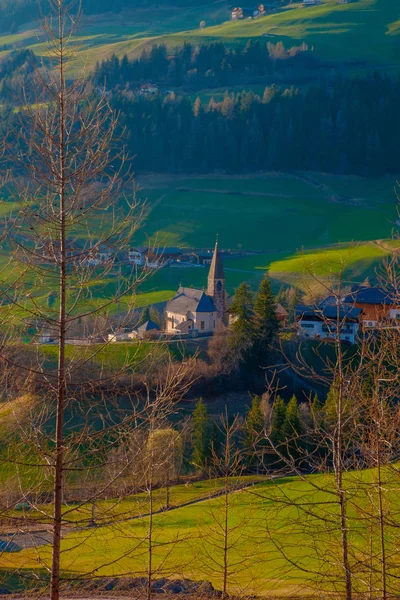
top-left (165, 241), bottom-right (226, 336)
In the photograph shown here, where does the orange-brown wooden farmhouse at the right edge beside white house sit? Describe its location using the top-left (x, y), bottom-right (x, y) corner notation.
top-left (343, 286), bottom-right (400, 328)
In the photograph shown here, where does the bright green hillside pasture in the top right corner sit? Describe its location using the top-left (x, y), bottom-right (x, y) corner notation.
top-left (153, 0), bottom-right (400, 68)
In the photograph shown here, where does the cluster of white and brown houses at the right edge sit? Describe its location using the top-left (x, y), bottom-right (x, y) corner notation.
top-left (295, 285), bottom-right (400, 344)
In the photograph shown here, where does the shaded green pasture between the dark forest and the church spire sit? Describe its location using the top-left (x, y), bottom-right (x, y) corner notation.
top-left (138, 173), bottom-right (397, 254)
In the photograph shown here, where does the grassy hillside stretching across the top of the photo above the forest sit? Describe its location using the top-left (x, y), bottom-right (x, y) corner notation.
top-left (0, 0), bottom-right (400, 75)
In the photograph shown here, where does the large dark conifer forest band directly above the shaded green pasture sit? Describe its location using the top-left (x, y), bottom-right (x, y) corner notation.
top-left (112, 74), bottom-right (400, 175)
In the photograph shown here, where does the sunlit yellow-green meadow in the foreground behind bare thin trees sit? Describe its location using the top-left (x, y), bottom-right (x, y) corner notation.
top-left (0, 472), bottom-right (398, 598)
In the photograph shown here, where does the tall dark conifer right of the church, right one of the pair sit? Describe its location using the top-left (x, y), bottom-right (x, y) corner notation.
top-left (254, 273), bottom-right (279, 363)
